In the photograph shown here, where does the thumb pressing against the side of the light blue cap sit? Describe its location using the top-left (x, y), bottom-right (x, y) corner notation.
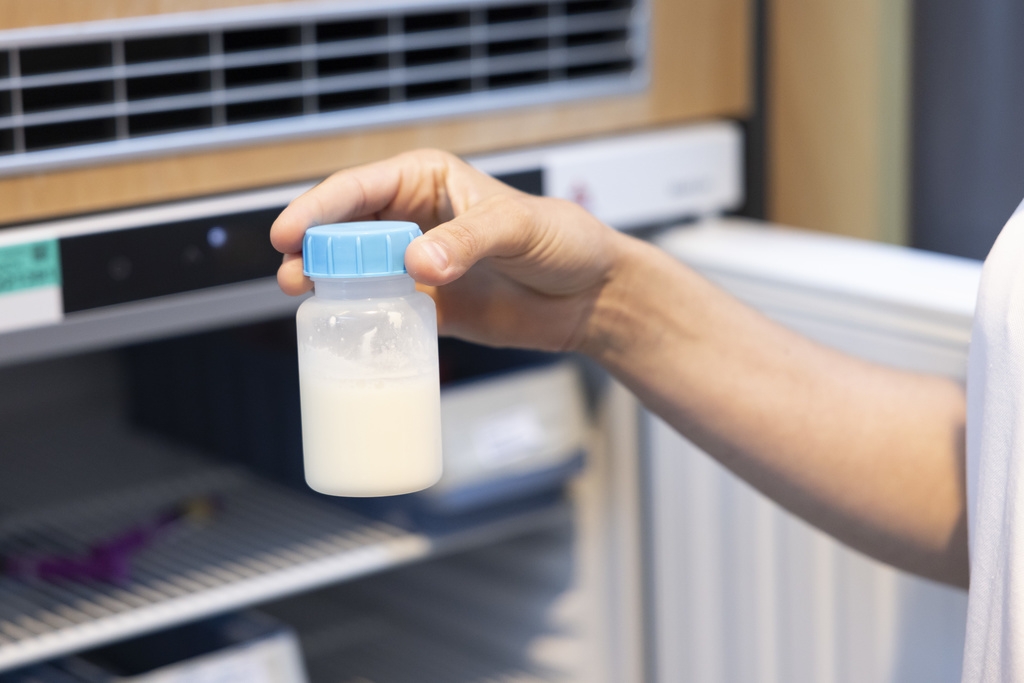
top-left (406, 195), bottom-right (540, 286)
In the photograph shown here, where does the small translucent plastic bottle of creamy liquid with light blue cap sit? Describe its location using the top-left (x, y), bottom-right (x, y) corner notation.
top-left (296, 221), bottom-right (441, 496)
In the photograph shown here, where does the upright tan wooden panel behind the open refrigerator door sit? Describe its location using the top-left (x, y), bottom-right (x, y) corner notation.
top-left (768, 0), bottom-right (909, 243)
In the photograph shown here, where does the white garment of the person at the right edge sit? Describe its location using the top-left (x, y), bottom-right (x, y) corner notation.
top-left (963, 194), bottom-right (1024, 683)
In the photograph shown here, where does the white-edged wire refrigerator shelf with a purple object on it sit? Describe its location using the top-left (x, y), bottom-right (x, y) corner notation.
top-left (0, 466), bottom-right (565, 671)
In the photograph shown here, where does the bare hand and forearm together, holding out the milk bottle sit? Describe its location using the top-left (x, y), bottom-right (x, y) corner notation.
top-left (270, 151), bottom-right (968, 588)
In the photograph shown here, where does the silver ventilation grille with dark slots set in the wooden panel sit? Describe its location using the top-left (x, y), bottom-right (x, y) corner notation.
top-left (0, 0), bottom-right (646, 172)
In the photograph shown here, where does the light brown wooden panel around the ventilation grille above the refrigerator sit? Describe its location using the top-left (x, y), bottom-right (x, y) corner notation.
top-left (0, 0), bottom-right (750, 223)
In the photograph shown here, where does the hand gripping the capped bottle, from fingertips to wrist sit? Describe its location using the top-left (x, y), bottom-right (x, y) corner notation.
top-left (270, 151), bottom-right (629, 350)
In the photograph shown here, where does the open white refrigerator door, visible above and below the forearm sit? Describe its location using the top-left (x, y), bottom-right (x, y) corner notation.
top-left (645, 219), bottom-right (980, 683)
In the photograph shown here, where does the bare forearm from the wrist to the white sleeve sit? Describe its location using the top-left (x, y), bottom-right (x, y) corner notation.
top-left (583, 238), bottom-right (968, 586)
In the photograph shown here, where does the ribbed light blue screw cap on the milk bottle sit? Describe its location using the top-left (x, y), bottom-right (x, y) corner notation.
top-left (302, 220), bottom-right (423, 279)
